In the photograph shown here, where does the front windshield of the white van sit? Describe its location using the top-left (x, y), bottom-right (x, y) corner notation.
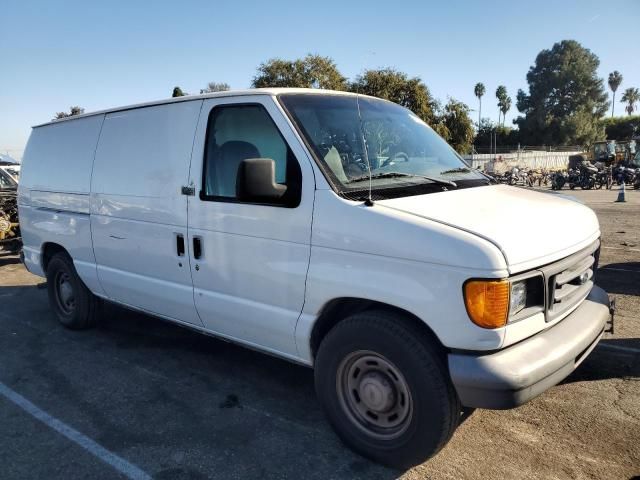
top-left (279, 94), bottom-right (487, 198)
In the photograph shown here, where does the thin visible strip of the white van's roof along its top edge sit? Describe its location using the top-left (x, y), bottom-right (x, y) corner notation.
top-left (32, 88), bottom-right (362, 128)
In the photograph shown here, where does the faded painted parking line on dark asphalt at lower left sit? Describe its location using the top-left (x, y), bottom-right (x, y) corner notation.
top-left (0, 382), bottom-right (151, 480)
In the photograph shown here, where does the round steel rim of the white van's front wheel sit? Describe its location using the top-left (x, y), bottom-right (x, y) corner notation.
top-left (336, 350), bottom-right (413, 440)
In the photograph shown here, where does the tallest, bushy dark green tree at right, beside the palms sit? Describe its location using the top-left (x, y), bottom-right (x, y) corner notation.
top-left (514, 40), bottom-right (609, 145)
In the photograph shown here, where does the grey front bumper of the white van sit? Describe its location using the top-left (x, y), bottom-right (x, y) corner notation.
top-left (448, 286), bottom-right (613, 409)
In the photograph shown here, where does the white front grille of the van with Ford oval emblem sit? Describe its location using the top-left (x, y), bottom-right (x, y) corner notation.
top-left (541, 240), bottom-right (600, 322)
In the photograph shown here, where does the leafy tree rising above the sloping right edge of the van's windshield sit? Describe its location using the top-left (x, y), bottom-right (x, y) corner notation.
top-left (349, 68), bottom-right (437, 125)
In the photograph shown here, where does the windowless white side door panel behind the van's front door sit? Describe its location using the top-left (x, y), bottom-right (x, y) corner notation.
top-left (91, 101), bottom-right (202, 325)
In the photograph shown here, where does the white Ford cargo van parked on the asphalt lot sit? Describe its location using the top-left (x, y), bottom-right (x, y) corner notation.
top-left (19, 89), bottom-right (612, 467)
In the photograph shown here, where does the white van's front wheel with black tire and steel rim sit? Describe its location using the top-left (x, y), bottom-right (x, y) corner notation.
top-left (315, 311), bottom-right (461, 469)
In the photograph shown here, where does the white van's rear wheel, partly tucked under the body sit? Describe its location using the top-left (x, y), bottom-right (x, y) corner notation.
top-left (47, 252), bottom-right (99, 330)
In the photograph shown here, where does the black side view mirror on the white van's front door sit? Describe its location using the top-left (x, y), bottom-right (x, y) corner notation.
top-left (236, 158), bottom-right (287, 203)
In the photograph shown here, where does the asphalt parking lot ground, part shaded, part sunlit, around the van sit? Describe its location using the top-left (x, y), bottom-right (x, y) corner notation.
top-left (0, 186), bottom-right (640, 480)
